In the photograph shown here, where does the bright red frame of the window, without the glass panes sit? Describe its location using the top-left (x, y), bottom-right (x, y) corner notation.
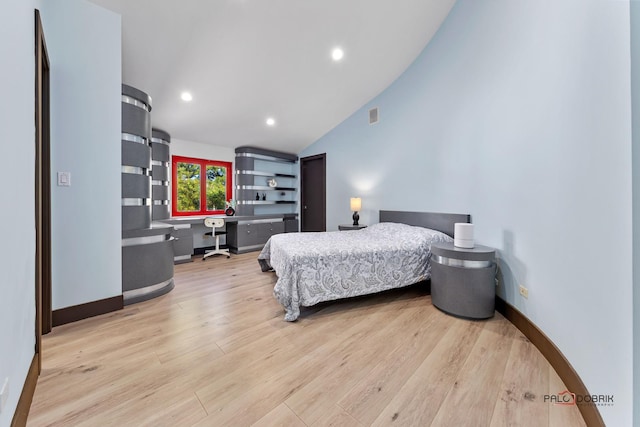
top-left (171, 156), bottom-right (233, 216)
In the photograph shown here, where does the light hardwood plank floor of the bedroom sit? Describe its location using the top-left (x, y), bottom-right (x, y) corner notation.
top-left (28, 252), bottom-right (584, 427)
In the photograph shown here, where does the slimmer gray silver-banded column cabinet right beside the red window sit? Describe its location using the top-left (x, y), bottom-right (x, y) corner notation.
top-left (151, 129), bottom-right (171, 221)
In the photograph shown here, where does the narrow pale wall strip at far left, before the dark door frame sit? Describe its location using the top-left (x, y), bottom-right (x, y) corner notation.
top-left (0, 0), bottom-right (39, 427)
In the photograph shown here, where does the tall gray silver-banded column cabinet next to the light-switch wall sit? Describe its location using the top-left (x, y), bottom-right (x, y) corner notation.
top-left (122, 84), bottom-right (151, 230)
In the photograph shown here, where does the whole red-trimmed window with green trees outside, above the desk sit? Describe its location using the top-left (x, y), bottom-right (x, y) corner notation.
top-left (171, 156), bottom-right (233, 216)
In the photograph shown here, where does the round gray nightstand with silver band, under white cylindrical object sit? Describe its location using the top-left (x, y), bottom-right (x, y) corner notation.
top-left (431, 243), bottom-right (496, 319)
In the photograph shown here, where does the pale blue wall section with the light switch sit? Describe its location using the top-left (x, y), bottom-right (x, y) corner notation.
top-left (42, 0), bottom-right (122, 310)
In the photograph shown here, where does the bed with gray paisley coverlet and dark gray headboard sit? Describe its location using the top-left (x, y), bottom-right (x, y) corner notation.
top-left (258, 211), bottom-right (471, 321)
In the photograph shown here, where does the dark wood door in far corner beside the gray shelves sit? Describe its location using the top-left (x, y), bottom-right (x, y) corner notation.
top-left (300, 154), bottom-right (327, 231)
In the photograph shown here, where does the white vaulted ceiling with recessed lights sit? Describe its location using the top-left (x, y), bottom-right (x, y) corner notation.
top-left (90, 0), bottom-right (455, 153)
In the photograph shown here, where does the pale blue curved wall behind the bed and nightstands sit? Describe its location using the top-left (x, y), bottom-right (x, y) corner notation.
top-left (301, 0), bottom-right (632, 426)
